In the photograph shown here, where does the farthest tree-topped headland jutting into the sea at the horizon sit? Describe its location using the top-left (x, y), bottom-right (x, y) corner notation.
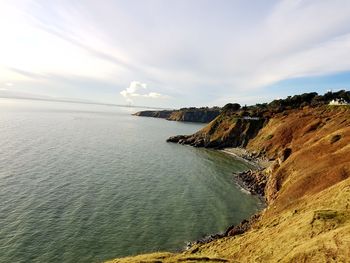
top-left (134, 107), bottom-right (220, 123)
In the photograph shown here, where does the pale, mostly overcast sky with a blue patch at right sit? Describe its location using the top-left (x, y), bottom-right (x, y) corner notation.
top-left (0, 0), bottom-right (350, 108)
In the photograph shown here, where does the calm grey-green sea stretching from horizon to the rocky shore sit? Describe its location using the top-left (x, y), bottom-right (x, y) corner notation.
top-left (0, 99), bottom-right (261, 262)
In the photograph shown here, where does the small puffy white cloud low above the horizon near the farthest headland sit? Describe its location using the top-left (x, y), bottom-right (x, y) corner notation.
top-left (120, 81), bottom-right (168, 103)
